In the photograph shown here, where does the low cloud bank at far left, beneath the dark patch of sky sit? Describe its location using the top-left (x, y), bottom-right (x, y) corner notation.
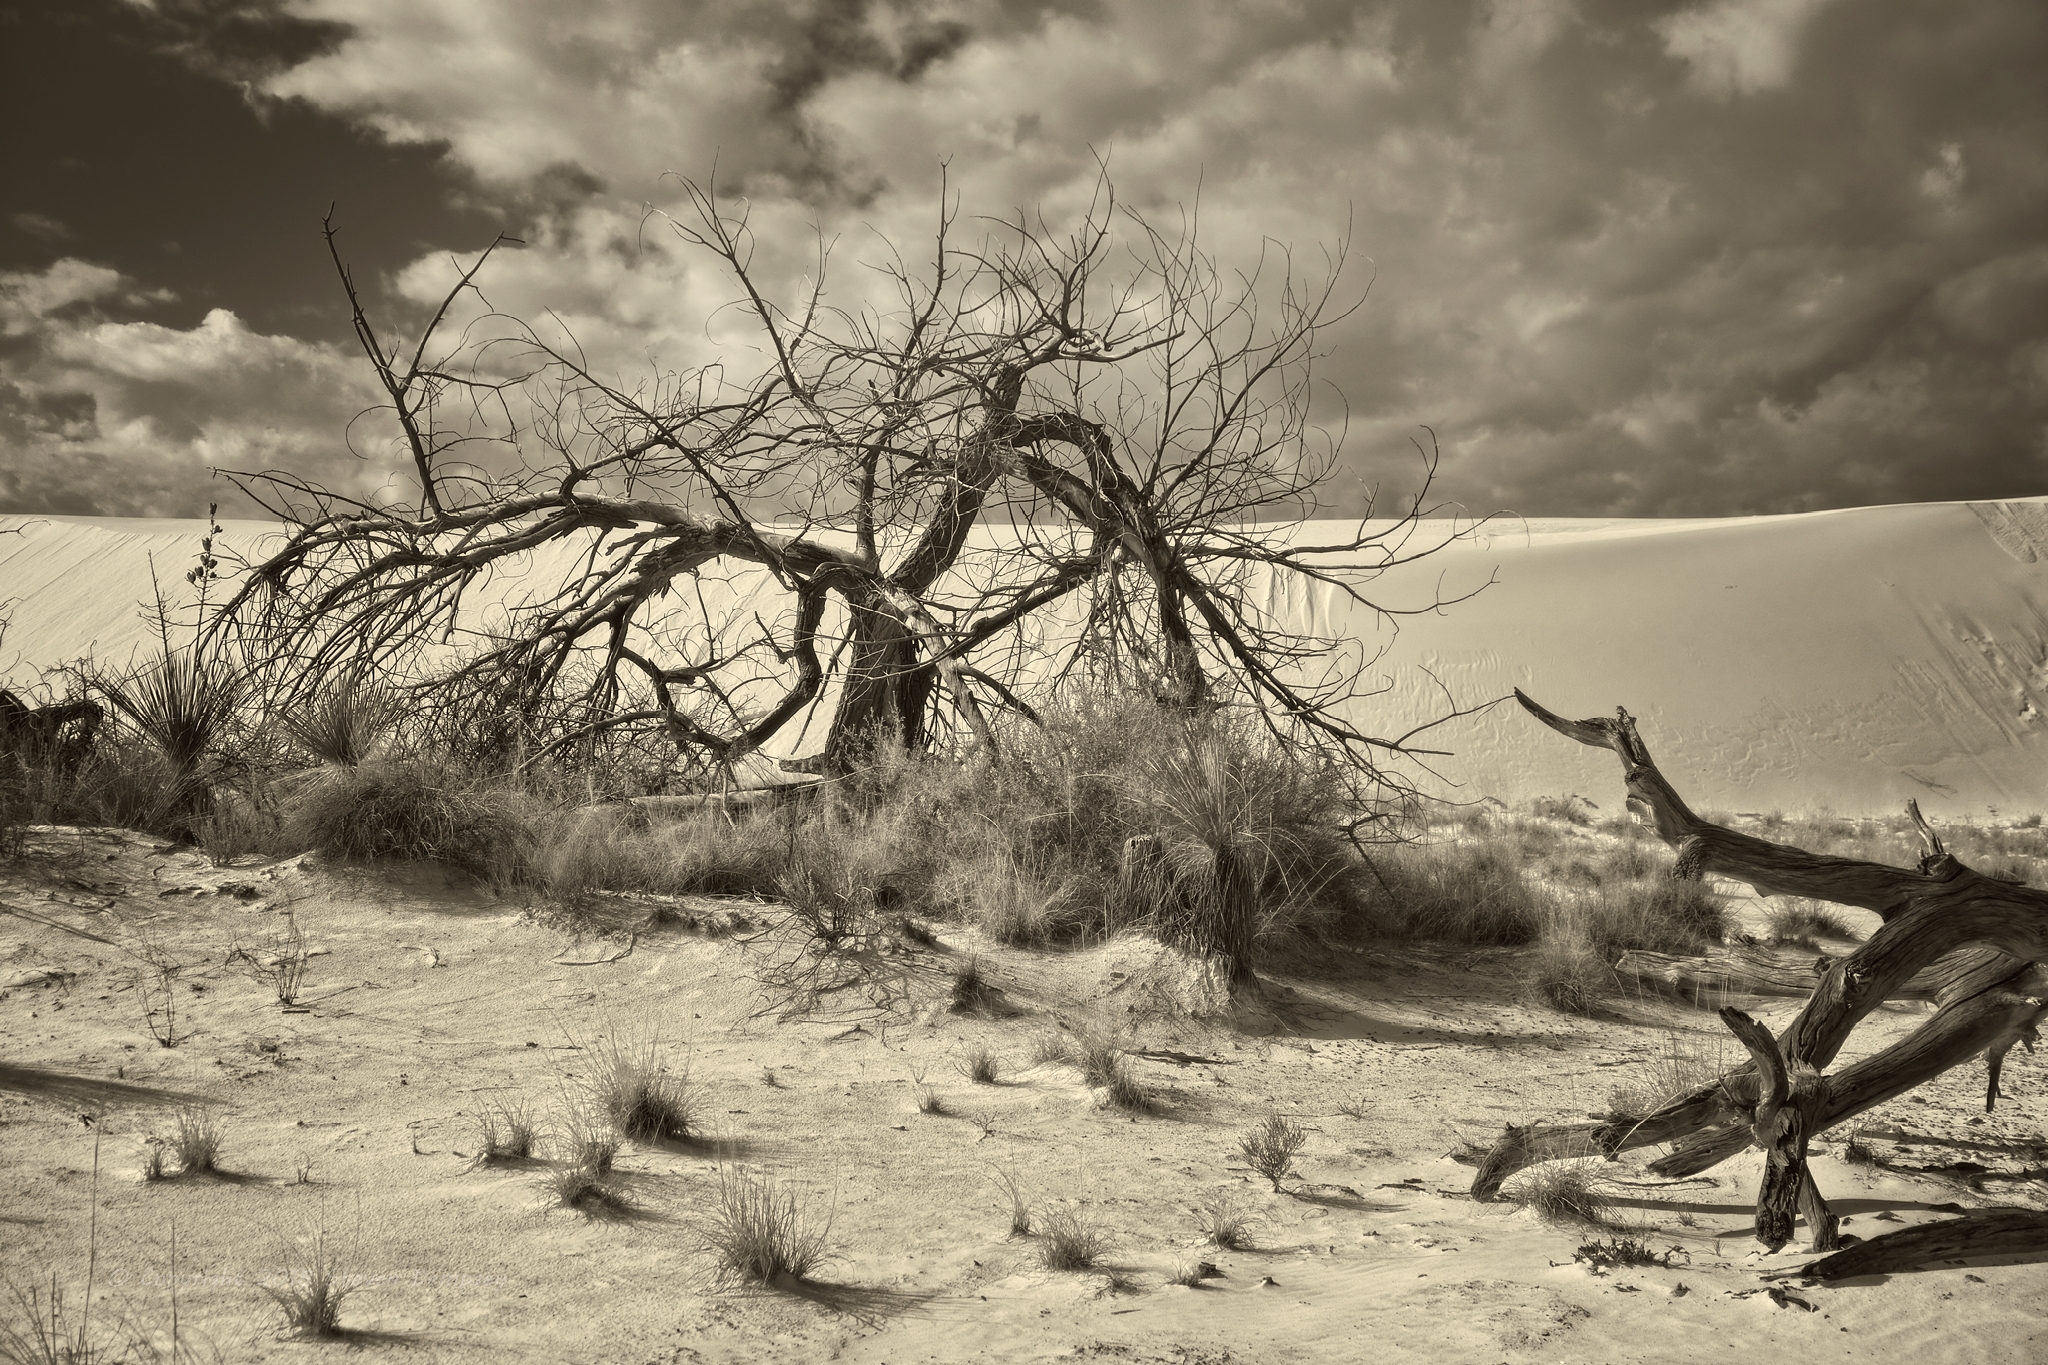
top-left (0, 258), bottom-right (389, 516)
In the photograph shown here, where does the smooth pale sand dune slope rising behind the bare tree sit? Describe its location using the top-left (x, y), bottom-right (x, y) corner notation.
top-left (0, 501), bottom-right (2048, 819)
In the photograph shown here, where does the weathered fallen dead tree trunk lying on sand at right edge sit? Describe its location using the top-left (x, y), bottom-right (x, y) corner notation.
top-left (1473, 690), bottom-right (2048, 1250)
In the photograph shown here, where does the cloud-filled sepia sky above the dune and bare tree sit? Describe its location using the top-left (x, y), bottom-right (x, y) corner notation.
top-left (0, 0), bottom-right (2048, 516)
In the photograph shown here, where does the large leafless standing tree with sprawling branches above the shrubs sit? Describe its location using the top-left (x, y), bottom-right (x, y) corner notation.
top-left (211, 182), bottom-right (1470, 808)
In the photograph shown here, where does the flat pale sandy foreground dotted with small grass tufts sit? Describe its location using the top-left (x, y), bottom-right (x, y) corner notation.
top-left (0, 831), bottom-right (2048, 1365)
